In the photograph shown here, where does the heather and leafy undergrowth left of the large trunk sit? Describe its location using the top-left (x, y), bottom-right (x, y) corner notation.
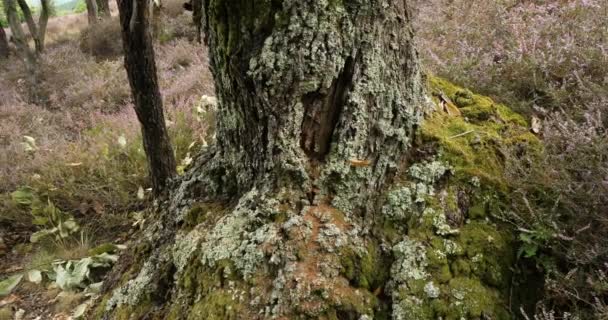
top-left (0, 2), bottom-right (214, 320)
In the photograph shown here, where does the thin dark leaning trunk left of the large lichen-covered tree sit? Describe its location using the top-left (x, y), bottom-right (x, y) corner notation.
top-left (118, 0), bottom-right (176, 195)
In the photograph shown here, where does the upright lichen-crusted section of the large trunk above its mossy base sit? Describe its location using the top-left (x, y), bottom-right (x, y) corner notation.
top-left (203, 1), bottom-right (424, 209)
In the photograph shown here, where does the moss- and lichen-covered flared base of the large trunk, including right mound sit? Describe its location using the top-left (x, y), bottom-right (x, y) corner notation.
top-left (96, 78), bottom-right (541, 320)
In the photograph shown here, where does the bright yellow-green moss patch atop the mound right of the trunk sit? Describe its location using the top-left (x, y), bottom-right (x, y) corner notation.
top-left (419, 77), bottom-right (541, 192)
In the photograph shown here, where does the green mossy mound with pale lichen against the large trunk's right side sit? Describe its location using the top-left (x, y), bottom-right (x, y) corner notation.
top-left (385, 78), bottom-right (541, 319)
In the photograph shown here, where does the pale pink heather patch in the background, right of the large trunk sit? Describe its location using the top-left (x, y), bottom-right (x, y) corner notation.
top-left (414, 0), bottom-right (608, 116)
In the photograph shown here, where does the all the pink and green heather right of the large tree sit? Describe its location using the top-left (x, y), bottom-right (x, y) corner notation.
top-left (414, 0), bottom-right (608, 319)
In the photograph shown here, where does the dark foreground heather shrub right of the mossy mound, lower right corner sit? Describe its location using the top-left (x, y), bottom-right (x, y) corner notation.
top-left (508, 106), bottom-right (608, 319)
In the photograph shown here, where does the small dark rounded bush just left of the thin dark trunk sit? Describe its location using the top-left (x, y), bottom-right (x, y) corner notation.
top-left (80, 17), bottom-right (122, 60)
